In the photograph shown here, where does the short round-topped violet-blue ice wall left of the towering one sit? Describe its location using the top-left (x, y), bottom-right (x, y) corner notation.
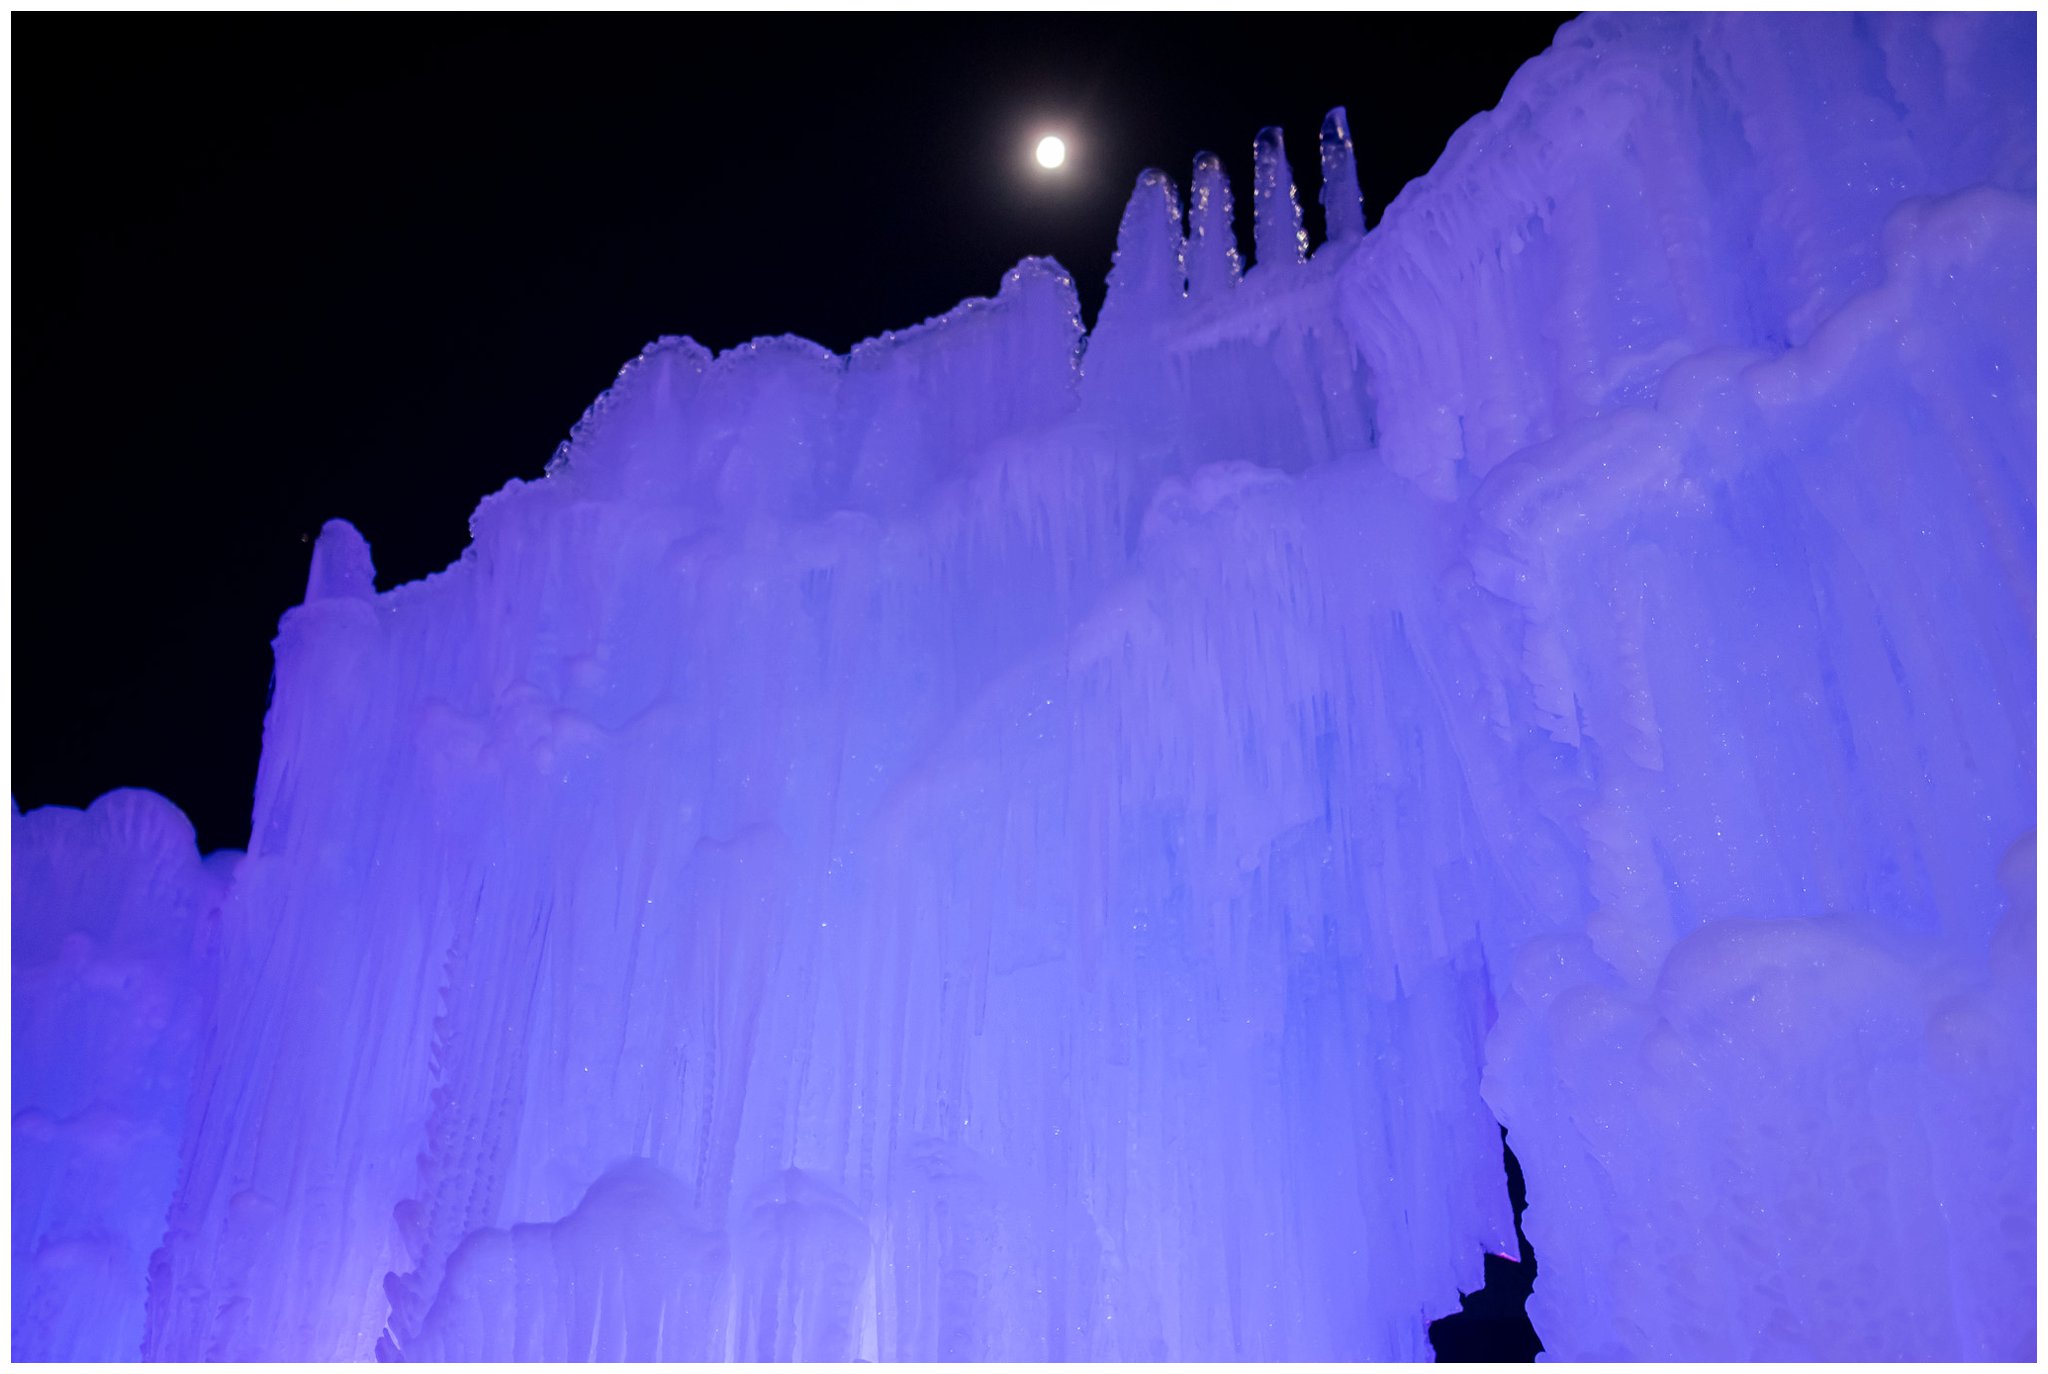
top-left (10, 790), bottom-right (238, 1360)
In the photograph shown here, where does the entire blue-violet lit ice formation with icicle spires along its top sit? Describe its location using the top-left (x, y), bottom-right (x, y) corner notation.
top-left (12, 14), bottom-right (2036, 1360)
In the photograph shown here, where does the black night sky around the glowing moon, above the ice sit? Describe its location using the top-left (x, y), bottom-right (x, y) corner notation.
top-left (12, 14), bottom-right (1567, 850)
